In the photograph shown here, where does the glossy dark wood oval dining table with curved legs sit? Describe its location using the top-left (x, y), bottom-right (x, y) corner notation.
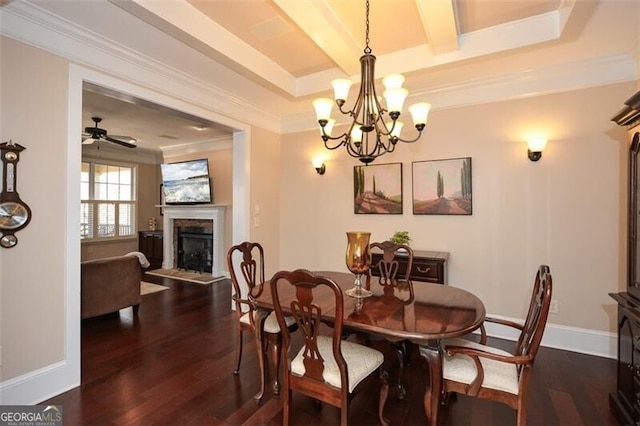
top-left (252, 271), bottom-right (485, 425)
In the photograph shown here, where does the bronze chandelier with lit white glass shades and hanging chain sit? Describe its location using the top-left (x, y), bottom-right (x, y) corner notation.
top-left (313, 0), bottom-right (431, 164)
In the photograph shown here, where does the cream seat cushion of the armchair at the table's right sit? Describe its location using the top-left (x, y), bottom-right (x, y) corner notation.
top-left (442, 339), bottom-right (518, 395)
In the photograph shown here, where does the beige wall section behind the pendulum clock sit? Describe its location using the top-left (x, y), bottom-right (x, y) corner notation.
top-left (0, 37), bottom-right (68, 381)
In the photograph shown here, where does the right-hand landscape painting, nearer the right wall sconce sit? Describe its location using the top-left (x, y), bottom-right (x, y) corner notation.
top-left (412, 157), bottom-right (473, 215)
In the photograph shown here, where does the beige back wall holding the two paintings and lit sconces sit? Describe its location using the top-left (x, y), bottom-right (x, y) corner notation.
top-left (280, 83), bottom-right (635, 332)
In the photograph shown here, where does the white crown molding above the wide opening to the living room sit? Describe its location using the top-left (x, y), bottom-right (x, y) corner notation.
top-left (0, 1), bottom-right (280, 132)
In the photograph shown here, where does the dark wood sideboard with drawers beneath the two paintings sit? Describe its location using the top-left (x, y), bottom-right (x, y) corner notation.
top-left (371, 250), bottom-right (449, 284)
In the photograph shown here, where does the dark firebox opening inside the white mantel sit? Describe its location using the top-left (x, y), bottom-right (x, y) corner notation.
top-left (174, 225), bottom-right (213, 273)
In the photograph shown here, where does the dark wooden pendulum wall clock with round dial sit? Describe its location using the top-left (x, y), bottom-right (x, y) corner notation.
top-left (0, 141), bottom-right (31, 248)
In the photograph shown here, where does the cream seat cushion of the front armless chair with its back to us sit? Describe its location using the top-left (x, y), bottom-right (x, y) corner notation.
top-left (291, 336), bottom-right (384, 392)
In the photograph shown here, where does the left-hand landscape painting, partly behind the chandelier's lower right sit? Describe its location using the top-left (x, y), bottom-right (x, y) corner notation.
top-left (353, 163), bottom-right (402, 214)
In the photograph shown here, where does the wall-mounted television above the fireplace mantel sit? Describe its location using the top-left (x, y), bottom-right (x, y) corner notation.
top-left (160, 158), bottom-right (213, 204)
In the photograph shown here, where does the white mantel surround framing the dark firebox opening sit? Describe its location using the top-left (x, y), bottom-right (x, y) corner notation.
top-left (157, 204), bottom-right (227, 277)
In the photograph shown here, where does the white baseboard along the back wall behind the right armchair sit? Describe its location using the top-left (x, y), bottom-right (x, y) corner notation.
top-left (485, 315), bottom-right (618, 359)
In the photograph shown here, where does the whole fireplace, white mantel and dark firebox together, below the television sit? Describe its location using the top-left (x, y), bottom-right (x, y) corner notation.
top-left (162, 204), bottom-right (226, 277)
